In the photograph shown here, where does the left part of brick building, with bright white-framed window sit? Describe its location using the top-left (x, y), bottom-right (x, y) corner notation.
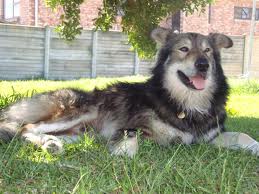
top-left (0, 0), bottom-right (102, 29)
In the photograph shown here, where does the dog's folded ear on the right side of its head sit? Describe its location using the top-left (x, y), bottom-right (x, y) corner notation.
top-left (209, 33), bottom-right (233, 49)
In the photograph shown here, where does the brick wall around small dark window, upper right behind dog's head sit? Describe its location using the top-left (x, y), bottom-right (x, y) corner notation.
top-left (182, 0), bottom-right (259, 35)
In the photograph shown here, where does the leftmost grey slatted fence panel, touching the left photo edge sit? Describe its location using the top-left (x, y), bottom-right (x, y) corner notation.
top-left (0, 25), bottom-right (44, 80)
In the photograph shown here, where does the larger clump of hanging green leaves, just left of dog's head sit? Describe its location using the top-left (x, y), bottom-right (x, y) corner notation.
top-left (95, 0), bottom-right (211, 58)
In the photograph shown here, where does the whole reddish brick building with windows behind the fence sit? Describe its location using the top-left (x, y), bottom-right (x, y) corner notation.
top-left (0, 0), bottom-right (259, 35)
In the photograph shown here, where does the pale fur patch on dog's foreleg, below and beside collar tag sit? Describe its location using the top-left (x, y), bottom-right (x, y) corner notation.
top-left (152, 119), bottom-right (193, 145)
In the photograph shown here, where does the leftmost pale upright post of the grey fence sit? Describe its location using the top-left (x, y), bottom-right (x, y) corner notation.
top-left (44, 26), bottom-right (50, 79)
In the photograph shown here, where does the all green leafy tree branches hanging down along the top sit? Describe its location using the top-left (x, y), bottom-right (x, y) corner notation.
top-left (45, 0), bottom-right (213, 57)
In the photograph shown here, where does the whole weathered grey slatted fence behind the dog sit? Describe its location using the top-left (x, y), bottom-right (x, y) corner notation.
top-left (0, 25), bottom-right (259, 80)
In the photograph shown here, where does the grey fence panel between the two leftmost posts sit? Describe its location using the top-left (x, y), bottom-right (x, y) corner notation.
top-left (49, 30), bottom-right (92, 80)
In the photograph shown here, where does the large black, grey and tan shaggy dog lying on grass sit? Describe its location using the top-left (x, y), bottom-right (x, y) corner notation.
top-left (0, 27), bottom-right (259, 157)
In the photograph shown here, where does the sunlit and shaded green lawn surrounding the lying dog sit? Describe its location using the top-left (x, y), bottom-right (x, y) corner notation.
top-left (0, 77), bottom-right (259, 193)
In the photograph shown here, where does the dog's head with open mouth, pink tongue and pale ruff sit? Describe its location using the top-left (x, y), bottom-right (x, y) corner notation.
top-left (151, 28), bottom-right (233, 112)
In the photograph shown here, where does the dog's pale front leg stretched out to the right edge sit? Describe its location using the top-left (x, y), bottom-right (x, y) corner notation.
top-left (211, 132), bottom-right (259, 156)
